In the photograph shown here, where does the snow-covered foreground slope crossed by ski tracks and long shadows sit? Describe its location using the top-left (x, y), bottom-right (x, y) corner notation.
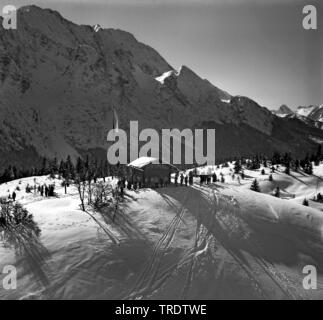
top-left (0, 163), bottom-right (323, 299)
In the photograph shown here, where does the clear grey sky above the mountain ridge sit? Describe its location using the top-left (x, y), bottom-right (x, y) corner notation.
top-left (0, 0), bottom-right (323, 108)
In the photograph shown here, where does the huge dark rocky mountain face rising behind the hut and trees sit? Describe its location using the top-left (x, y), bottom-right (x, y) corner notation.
top-left (0, 6), bottom-right (323, 170)
